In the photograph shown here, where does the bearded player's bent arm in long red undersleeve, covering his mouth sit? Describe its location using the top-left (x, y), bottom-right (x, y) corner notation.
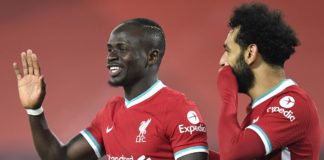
top-left (217, 66), bottom-right (265, 159)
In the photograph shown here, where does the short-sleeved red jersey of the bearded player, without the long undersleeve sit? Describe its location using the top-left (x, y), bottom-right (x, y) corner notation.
top-left (242, 79), bottom-right (321, 160)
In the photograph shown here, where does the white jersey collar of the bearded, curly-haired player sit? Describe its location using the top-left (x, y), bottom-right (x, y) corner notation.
top-left (251, 79), bottom-right (297, 109)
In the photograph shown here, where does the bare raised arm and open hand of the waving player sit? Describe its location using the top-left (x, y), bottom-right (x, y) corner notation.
top-left (13, 50), bottom-right (97, 159)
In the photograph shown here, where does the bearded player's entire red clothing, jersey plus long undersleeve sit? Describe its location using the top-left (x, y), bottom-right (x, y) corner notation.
top-left (217, 66), bottom-right (321, 160)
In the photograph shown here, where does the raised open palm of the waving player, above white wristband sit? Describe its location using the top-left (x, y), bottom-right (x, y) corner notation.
top-left (13, 49), bottom-right (46, 109)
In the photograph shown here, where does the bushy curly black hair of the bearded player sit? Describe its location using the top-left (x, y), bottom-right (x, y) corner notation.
top-left (229, 3), bottom-right (300, 67)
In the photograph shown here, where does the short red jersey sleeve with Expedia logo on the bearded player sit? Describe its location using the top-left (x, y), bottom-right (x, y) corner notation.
top-left (247, 92), bottom-right (310, 154)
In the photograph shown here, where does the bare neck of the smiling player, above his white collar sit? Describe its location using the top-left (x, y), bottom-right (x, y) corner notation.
top-left (124, 76), bottom-right (158, 100)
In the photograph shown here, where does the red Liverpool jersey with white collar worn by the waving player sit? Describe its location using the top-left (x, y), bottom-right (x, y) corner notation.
top-left (81, 81), bottom-right (208, 160)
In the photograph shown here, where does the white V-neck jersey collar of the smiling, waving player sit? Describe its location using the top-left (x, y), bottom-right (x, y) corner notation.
top-left (125, 80), bottom-right (165, 108)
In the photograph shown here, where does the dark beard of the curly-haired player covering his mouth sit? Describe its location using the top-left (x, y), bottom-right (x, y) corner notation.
top-left (233, 50), bottom-right (255, 94)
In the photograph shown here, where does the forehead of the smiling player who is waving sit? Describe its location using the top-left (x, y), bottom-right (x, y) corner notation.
top-left (108, 24), bottom-right (143, 45)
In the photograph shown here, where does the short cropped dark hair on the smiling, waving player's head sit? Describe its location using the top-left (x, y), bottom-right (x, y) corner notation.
top-left (123, 18), bottom-right (165, 58)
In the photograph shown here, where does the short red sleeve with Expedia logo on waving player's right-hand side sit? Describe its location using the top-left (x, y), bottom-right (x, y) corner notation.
top-left (165, 95), bottom-right (208, 159)
